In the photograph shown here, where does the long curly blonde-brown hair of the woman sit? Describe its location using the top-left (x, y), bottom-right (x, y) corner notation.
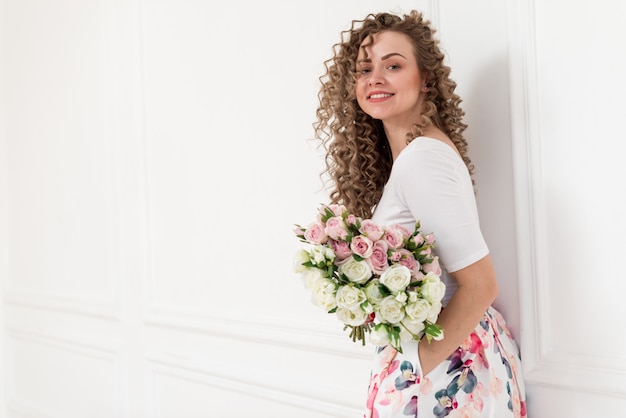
top-left (314, 10), bottom-right (474, 217)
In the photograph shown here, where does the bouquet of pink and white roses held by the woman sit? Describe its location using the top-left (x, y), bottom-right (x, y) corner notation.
top-left (294, 204), bottom-right (445, 352)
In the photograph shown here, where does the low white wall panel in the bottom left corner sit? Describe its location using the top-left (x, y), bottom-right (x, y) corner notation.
top-left (7, 331), bottom-right (122, 418)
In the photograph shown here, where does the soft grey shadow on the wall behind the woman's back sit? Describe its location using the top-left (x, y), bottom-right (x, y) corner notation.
top-left (459, 54), bottom-right (520, 336)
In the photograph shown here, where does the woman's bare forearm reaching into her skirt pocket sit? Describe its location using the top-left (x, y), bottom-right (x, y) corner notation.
top-left (419, 255), bottom-right (498, 376)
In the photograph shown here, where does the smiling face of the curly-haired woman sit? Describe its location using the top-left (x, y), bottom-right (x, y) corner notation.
top-left (356, 31), bottom-right (425, 130)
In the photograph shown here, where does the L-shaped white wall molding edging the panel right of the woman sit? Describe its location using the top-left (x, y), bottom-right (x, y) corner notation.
top-left (507, 0), bottom-right (626, 398)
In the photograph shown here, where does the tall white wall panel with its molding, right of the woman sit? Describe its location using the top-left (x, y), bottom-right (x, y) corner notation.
top-left (510, 2), bottom-right (626, 406)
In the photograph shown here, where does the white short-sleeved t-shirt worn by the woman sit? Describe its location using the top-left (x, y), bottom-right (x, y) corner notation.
top-left (372, 137), bottom-right (489, 306)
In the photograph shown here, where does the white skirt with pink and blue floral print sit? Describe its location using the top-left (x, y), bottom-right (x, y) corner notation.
top-left (364, 307), bottom-right (526, 418)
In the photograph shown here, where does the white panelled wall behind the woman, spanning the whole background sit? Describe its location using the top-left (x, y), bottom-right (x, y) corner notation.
top-left (0, 0), bottom-right (626, 418)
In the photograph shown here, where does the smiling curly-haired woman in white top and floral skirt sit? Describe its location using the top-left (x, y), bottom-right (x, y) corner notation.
top-left (315, 11), bottom-right (526, 418)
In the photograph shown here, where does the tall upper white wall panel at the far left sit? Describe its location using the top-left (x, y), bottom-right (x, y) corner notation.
top-left (3, 0), bottom-right (117, 314)
